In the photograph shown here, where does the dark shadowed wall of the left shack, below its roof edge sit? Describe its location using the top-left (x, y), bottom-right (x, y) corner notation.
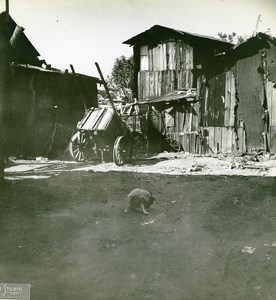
top-left (6, 67), bottom-right (97, 157)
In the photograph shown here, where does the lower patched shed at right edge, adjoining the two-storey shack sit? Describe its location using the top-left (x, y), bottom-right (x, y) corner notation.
top-left (199, 33), bottom-right (276, 154)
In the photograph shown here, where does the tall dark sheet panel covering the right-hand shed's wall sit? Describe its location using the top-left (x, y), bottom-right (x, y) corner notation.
top-left (236, 53), bottom-right (264, 151)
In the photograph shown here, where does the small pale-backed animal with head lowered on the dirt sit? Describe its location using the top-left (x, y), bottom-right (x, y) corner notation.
top-left (125, 189), bottom-right (155, 215)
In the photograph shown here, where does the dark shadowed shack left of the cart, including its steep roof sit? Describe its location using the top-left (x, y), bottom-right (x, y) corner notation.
top-left (0, 12), bottom-right (100, 157)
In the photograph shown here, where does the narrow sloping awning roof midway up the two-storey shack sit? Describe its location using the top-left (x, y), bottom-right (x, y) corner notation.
top-left (139, 89), bottom-right (198, 104)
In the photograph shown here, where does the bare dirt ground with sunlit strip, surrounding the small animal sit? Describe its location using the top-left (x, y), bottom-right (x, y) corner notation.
top-left (0, 154), bottom-right (276, 300)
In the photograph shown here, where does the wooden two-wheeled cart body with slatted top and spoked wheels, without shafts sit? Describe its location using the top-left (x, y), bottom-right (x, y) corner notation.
top-left (69, 107), bottom-right (136, 165)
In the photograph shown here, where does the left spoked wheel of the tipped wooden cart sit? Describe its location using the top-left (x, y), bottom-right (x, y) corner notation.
top-left (69, 132), bottom-right (89, 161)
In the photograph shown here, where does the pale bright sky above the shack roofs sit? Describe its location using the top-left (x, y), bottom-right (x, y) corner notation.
top-left (0, 0), bottom-right (276, 77)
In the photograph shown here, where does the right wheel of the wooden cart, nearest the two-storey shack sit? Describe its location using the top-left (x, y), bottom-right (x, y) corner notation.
top-left (113, 136), bottom-right (131, 166)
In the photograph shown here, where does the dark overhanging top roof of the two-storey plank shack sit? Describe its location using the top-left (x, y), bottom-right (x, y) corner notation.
top-left (123, 25), bottom-right (232, 47)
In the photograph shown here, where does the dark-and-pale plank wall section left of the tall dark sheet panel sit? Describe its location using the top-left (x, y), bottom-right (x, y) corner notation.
top-left (197, 70), bottom-right (237, 154)
